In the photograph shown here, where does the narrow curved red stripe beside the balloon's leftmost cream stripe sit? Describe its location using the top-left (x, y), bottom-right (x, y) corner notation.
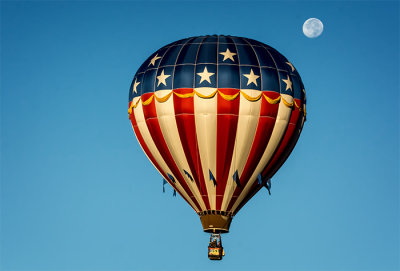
top-left (142, 93), bottom-right (201, 210)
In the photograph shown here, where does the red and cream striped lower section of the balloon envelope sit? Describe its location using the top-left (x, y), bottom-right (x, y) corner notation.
top-left (130, 88), bottom-right (304, 217)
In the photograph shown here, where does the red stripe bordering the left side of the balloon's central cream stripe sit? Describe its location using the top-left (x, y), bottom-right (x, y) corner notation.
top-left (173, 89), bottom-right (210, 210)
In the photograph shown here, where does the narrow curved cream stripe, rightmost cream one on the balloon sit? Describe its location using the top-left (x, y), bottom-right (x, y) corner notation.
top-left (232, 94), bottom-right (293, 212)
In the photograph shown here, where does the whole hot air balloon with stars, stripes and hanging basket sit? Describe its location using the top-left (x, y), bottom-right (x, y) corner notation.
top-left (128, 35), bottom-right (306, 259)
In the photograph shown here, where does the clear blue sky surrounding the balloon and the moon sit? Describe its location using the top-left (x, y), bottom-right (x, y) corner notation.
top-left (0, 1), bottom-right (400, 271)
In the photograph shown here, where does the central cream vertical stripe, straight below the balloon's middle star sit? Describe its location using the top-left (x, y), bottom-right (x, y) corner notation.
top-left (194, 88), bottom-right (218, 210)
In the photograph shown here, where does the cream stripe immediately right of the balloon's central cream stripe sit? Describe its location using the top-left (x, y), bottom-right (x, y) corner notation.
top-left (221, 90), bottom-right (263, 211)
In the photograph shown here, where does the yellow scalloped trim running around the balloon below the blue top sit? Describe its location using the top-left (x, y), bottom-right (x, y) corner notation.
top-left (128, 89), bottom-right (306, 116)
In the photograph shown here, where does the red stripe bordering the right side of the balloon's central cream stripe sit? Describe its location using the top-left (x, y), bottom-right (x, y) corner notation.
top-left (213, 89), bottom-right (240, 210)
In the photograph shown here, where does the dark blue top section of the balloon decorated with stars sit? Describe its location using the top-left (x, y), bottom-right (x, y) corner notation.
top-left (129, 35), bottom-right (305, 104)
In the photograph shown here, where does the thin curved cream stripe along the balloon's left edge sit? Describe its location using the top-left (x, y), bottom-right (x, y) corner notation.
top-left (134, 101), bottom-right (200, 215)
